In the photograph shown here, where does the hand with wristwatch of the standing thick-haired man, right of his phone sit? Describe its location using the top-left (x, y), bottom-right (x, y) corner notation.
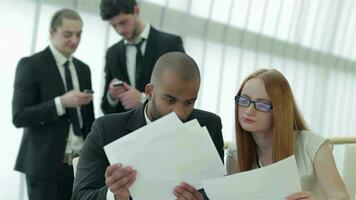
top-left (119, 83), bottom-right (141, 110)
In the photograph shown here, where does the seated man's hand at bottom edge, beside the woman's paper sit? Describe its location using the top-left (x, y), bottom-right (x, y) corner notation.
top-left (173, 183), bottom-right (204, 200)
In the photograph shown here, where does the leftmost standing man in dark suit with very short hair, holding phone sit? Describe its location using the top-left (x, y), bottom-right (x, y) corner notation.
top-left (12, 9), bottom-right (94, 200)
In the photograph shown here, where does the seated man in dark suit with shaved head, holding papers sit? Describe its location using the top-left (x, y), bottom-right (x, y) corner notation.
top-left (72, 52), bottom-right (224, 200)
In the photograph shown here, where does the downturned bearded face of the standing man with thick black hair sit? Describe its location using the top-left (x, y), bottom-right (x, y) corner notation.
top-left (110, 6), bottom-right (140, 42)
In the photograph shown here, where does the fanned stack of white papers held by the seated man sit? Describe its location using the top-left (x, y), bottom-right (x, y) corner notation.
top-left (104, 114), bottom-right (225, 200)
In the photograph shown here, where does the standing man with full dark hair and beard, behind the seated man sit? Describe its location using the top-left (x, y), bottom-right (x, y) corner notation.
top-left (100, 0), bottom-right (184, 114)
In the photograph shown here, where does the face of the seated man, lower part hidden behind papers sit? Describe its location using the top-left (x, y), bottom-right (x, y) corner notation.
top-left (146, 71), bottom-right (199, 121)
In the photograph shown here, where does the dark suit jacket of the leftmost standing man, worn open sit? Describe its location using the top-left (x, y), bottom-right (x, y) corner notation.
top-left (12, 47), bottom-right (94, 177)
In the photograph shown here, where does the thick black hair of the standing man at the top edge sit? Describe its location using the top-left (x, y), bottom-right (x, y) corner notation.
top-left (100, 0), bottom-right (137, 20)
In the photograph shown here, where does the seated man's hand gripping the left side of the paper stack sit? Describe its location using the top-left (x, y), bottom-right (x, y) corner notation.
top-left (105, 164), bottom-right (137, 200)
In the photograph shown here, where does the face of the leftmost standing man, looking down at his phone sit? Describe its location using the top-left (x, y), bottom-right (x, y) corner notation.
top-left (50, 18), bottom-right (82, 57)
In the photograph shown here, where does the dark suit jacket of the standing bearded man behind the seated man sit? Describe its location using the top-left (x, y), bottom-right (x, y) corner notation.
top-left (101, 26), bottom-right (184, 114)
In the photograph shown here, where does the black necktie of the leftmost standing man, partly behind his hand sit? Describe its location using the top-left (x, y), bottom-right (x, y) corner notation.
top-left (63, 61), bottom-right (82, 136)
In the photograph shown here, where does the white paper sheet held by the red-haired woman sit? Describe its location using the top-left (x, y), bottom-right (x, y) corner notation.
top-left (203, 155), bottom-right (301, 200)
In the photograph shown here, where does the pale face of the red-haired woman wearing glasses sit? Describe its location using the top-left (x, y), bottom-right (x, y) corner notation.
top-left (238, 78), bottom-right (273, 133)
